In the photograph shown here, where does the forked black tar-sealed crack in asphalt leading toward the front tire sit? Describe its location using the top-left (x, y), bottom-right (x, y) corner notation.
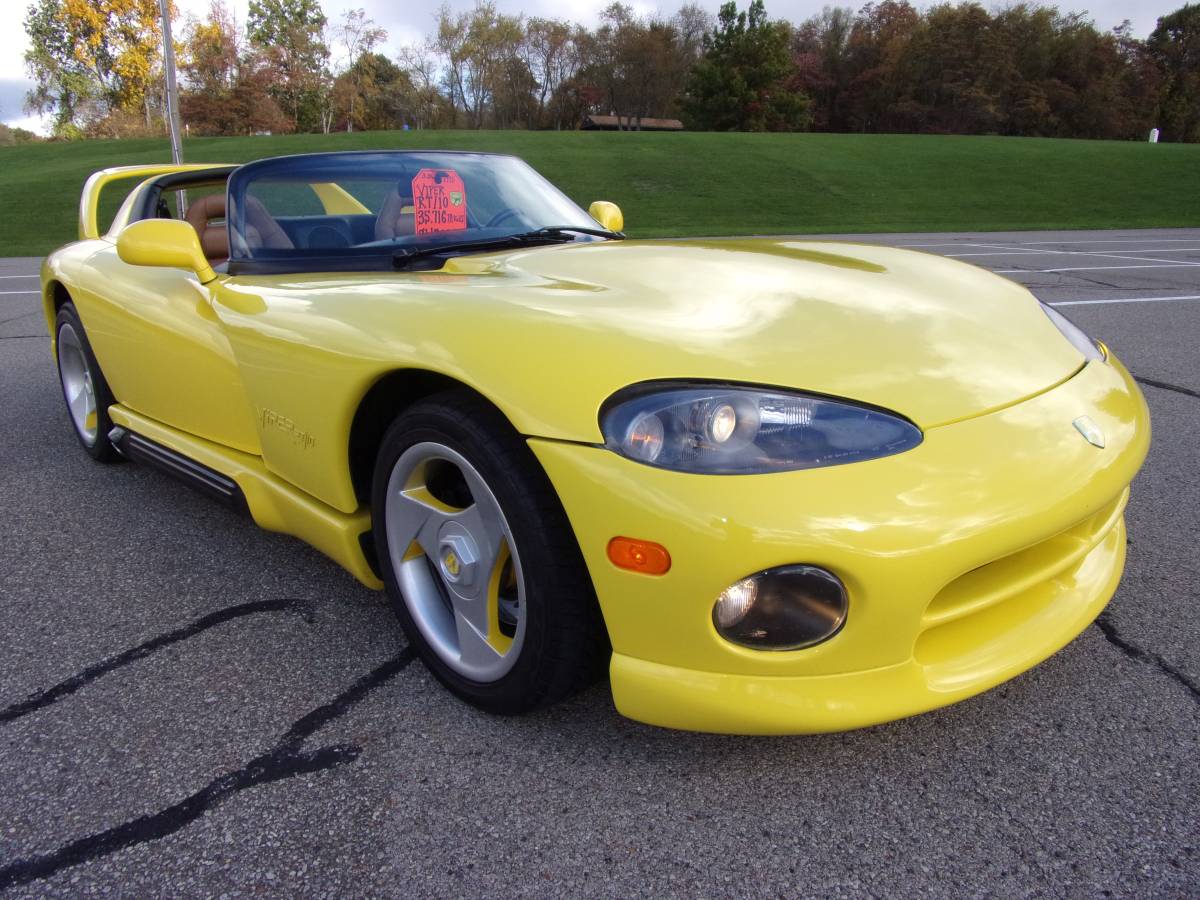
top-left (0, 647), bottom-right (415, 890)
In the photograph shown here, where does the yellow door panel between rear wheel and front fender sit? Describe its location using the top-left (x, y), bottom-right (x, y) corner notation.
top-left (77, 247), bottom-right (262, 455)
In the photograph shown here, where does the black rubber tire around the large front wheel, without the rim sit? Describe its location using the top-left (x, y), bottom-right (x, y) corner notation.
top-left (371, 390), bottom-right (611, 715)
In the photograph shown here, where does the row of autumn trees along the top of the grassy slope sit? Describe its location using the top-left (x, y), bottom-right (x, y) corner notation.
top-left (16, 0), bottom-right (1200, 142)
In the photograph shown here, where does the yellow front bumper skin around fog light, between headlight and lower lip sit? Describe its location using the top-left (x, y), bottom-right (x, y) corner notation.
top-left (529, 361), bottom-right (1150, 676)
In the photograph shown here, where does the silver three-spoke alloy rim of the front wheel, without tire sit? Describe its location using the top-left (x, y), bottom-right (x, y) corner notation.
top-left (384, 442), bottom-right (527, 683)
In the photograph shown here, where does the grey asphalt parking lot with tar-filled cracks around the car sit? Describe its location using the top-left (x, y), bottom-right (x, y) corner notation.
top-left (0, 229), bottom-right (1200, 896)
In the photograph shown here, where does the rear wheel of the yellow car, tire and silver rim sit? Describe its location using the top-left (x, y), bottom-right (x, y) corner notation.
top-left (54, 302), bottom-right (120, 462)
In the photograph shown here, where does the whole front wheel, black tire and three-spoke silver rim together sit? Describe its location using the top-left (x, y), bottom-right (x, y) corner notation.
top-left (372, 391), bottom-right (607, 714)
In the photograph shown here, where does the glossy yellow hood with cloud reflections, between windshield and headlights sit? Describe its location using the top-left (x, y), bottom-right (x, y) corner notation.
top-left (223, 239), bottom-right (1084, 440)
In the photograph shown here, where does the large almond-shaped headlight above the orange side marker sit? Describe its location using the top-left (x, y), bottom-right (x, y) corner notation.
top-left (600, 383), bottom-right (922, 475)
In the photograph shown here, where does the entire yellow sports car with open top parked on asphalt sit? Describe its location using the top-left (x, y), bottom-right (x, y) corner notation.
top-left (42, 151), bottom-right (1150, 733)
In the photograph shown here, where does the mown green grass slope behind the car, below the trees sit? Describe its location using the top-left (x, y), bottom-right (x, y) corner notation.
top-left (0, 131), bottom-right (1200, 256)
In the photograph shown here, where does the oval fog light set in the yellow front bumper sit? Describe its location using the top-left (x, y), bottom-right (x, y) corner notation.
top-left (713, 565), bottom-right (850, 650)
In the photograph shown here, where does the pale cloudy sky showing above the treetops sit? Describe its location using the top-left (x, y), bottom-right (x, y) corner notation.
top-left (0, 0), bottom-right (1186, 131)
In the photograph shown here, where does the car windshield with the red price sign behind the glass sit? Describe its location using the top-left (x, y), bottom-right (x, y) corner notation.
top-left (229, 151), bottom-right (602, 271)
